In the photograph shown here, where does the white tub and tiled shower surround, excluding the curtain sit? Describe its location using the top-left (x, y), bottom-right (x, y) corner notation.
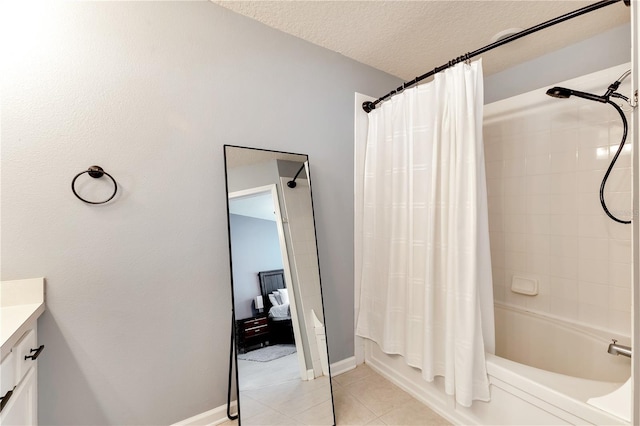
top-left (356, 64), bottom-right (637, 424)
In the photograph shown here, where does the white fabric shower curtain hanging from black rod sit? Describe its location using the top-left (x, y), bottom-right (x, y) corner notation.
top-left (356, 61), bottom-right (495, 407)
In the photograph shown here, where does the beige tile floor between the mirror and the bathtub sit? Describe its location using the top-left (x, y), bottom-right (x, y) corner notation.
top-left (222, 365), bottom-right (451, 426)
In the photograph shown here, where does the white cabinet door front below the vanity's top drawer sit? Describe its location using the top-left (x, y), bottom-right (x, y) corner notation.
top-left (0, 366), bottom-right (38, 426)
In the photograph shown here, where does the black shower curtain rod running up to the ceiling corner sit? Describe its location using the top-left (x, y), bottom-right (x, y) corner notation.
top-left (362, 0), bottom-right (631, 113)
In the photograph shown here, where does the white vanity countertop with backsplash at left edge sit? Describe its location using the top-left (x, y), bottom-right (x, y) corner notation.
top-left (0, 278), bottom-right (45, 359)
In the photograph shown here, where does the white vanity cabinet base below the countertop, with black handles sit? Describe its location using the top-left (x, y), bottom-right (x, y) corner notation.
top-left (0, 327), bottom-right (42, 426)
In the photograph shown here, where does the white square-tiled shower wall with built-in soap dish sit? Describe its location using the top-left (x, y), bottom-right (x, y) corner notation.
top-left (484, 67), bottom-right (632, 335)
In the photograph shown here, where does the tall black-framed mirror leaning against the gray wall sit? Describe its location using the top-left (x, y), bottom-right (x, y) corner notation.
top-left (224, 145), bottom-right (335, 425)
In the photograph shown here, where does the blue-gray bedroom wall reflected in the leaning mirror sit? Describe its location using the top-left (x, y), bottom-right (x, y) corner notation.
top-left (229, 214), bottom-right (282, 319)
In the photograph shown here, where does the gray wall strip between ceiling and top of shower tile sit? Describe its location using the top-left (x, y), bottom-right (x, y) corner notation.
top-left (484, 24), bottom-right (631, 104)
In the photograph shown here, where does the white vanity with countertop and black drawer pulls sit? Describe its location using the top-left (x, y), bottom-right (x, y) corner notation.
top-left (0, 278), bottom-right (45, 426)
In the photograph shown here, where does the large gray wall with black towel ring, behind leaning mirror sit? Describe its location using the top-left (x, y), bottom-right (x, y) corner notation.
top-left (1, 2), bottom-right (400, 425)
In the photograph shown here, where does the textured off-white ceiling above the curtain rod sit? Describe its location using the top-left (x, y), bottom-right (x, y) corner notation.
top-left (212, 0), bottom-right (629, 80)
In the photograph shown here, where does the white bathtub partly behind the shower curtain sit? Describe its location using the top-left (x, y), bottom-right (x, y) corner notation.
top-left (364, 303), bottom-right (631, 425)
